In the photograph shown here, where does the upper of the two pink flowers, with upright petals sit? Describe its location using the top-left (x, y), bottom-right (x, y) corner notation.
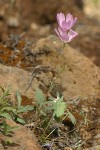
top-left (57, 13), bottom-right (77, 30)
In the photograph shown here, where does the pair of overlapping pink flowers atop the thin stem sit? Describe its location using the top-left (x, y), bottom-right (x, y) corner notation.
top-left (55, 13), bottom-right (78, 43)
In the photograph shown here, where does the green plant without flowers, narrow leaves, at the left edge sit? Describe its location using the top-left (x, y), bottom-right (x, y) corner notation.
top-left (0, 86), bottom-right (34, 135)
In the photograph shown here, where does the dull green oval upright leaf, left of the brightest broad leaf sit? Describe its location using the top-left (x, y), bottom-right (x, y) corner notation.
top-left (35, 89), bottom-right (46, 105)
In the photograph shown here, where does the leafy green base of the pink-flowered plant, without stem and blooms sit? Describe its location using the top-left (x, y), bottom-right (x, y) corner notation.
top-left (35, 89), bottom-right (76, 140)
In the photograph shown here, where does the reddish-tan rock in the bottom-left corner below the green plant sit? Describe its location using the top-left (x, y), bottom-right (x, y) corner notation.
top-left (0, 120), bottom-right (41, 150)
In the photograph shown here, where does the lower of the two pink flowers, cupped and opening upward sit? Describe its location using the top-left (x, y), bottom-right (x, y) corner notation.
top-left (55, 27), bottom-right (78, 43)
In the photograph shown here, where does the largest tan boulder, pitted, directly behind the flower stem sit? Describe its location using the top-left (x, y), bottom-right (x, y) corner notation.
top-left (29, 36), bottom-right (100, 98)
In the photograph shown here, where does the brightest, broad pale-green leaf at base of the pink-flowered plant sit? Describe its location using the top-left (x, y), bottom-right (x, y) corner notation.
top-left (53, 101), bottom-right (66, 117)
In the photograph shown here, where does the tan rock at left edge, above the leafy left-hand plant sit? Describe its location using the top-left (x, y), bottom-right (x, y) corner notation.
top-left (0, 64), bottom-right (38, 97)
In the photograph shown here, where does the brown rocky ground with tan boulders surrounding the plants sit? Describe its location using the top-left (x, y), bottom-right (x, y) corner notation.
top-left (0, 0), bottom-right (100, 150)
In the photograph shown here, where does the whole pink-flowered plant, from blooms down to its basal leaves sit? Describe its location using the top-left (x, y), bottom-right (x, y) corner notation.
top-left (32, 13), bottom-right (78, 140)
